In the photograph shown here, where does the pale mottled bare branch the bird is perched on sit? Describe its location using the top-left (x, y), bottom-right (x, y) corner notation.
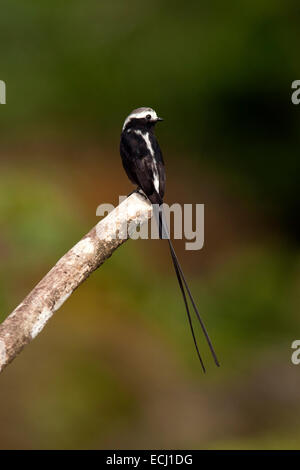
top-left (0, 193), bottom-right (152, 372)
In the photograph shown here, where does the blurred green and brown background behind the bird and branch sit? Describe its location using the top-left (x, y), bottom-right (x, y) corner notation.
top-left (0, 0), bottom-right (300, 449)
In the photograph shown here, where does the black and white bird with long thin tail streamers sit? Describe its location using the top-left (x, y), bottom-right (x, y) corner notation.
top-left (120, 107), bottom-right (220, 372)
